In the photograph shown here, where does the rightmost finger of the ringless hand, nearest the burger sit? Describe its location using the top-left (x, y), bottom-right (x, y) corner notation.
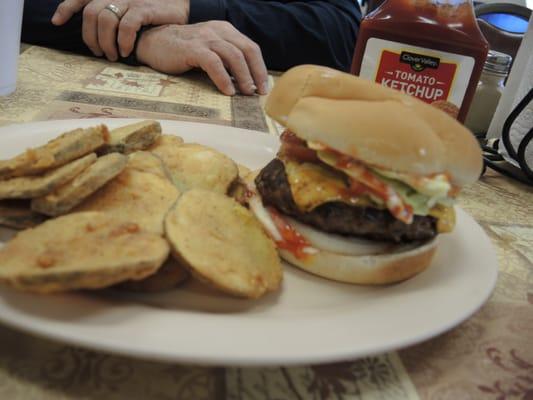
top-left (222, 31), bottom-right (268, 94)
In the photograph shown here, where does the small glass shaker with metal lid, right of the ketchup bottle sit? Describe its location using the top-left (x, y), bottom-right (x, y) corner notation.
top-left (465, 50), bottom-right (512, 133)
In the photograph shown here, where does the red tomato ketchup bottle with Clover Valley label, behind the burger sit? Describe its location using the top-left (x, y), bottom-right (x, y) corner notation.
top-left (351, 0), bottom-right (489, 122)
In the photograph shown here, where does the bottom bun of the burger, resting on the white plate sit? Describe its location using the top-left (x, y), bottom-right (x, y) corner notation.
top-left (278, 238), bottom-right (437, 285)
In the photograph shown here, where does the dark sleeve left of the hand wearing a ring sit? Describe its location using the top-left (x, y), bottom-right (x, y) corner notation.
top-left (21, 0), bottom-right (92, 55)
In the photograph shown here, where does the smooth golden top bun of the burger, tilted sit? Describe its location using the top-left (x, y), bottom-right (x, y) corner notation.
top-left (265, 65), bottom-right (482, 186)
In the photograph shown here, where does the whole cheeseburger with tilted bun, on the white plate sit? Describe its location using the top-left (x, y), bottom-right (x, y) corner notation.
top-left (248, 65), bottom-right (482, 284)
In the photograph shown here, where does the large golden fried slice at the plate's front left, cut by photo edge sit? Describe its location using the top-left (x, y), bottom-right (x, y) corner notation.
top-left (0, 212), bottom-right (169, 293)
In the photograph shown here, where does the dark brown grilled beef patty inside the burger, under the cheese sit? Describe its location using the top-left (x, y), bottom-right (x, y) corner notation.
top-left (255, 158), bottom-right (437, 243)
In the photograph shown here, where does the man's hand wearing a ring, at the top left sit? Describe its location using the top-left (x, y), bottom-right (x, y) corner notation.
top-left (52, 0), bottom-right (189, 61)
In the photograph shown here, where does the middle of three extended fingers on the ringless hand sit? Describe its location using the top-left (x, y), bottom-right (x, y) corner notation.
top-left (210, 40), bottom-right (257, 95)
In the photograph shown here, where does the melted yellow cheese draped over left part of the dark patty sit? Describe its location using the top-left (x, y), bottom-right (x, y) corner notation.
top-left (283, 160), bottom-right (376, 212)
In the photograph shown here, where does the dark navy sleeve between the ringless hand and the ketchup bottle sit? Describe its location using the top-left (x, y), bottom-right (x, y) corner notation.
top-left (189, 0), bottom-right (361, 71)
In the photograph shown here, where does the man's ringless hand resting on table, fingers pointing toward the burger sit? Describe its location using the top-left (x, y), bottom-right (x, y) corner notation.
top-left (137, 21), bottom-right (268, 96)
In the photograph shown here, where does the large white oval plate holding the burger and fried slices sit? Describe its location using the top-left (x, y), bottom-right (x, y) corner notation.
top-left (0, 120), bottom-right (498, 365)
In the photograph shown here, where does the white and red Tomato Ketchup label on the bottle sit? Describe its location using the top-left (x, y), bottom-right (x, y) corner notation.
top-left (359, 38), bottom-right (475, 114)
